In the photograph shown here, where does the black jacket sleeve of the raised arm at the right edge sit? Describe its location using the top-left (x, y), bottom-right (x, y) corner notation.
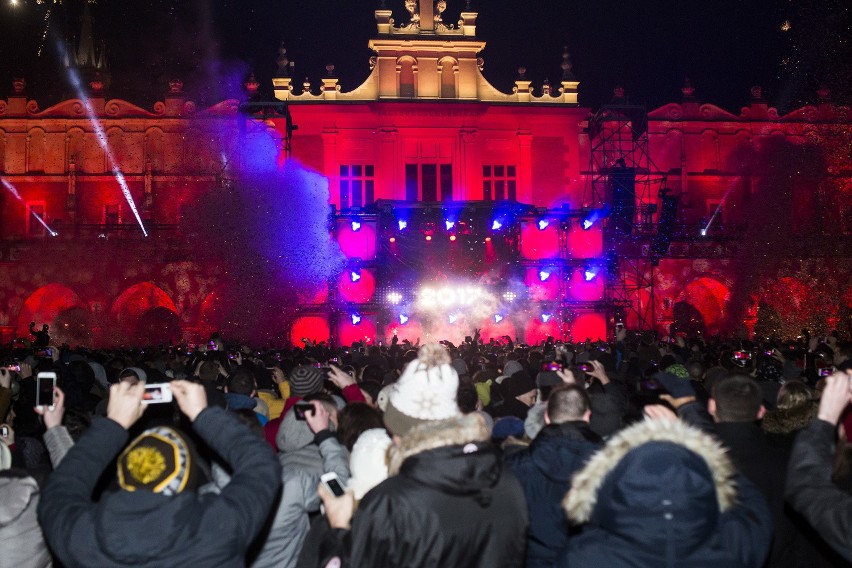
top-left (786, 419), bottom-right (852, 561)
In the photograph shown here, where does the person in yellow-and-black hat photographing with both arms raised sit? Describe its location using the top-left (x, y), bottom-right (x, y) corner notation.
top-left (38, 381), bottom-right (281, 568)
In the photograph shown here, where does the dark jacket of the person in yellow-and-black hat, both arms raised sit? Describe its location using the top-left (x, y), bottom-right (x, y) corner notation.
top-left (38, 407), bottom-right (281, 568)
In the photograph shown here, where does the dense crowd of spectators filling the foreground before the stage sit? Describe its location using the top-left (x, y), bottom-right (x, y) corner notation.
top-left (0, 326), bottom-right (852, 568)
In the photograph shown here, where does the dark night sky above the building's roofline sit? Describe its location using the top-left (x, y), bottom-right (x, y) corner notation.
top-left (0, 0), bottom-right (852, 112)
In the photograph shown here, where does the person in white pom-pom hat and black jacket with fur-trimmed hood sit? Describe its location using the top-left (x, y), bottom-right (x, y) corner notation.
top-left (320, 344), bottom-right (527, 568)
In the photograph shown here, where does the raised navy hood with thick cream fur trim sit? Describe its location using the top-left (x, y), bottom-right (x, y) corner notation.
top-left (562, 420), bottom-right (737, 547)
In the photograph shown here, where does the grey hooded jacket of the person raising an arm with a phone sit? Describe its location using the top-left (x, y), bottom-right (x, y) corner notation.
top-left (252, 409), bottom-right (349, 568)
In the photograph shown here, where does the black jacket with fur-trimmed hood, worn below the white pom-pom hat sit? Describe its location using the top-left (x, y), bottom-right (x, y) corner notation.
top-left (342, 415), bottom-right (527, 568)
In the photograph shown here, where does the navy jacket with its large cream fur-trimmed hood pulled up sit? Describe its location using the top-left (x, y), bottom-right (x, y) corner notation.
top-left (556, 420), bottom-right (772, 568)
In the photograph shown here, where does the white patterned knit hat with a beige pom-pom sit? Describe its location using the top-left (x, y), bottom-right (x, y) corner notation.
top-left (385, 343), bottom-right (459, 436)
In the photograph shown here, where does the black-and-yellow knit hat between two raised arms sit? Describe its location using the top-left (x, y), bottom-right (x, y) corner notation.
top-left (118, 427), bottom-right (195, 497)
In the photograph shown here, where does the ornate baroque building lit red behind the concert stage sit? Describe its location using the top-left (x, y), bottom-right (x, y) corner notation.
top-left (0, 0), bottom-right (852, 344)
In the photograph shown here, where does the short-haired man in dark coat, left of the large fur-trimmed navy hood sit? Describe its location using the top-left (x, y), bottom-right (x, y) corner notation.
top-left (506, 385), bottom-right (603, 568)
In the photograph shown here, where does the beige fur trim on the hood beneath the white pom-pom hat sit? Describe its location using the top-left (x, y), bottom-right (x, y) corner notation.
top-left (388, 412), bottom-right (491, 475)
